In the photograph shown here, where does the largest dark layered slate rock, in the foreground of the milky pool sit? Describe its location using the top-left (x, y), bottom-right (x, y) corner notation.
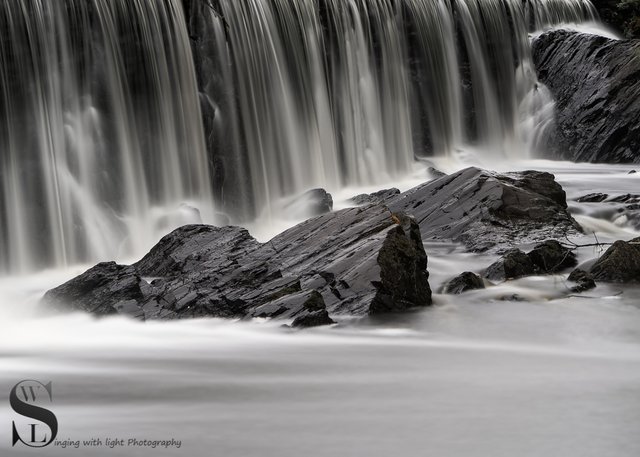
top-left (43, 205), bottom-right (431, 327)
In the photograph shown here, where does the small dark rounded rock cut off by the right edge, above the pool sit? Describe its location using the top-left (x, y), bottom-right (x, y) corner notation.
top-left (590, 238), bottom-right (640, 283)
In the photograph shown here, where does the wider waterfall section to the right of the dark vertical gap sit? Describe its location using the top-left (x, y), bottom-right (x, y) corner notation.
top-left (191, 0), bottom-right (595, 217)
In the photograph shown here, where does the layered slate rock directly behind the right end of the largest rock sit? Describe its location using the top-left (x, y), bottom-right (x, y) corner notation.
top-left (388, 167), bottom-right (582, 251)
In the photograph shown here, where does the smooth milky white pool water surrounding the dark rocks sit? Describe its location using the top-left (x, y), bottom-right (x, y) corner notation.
top-left (0, 160), bottom-right (640, 457)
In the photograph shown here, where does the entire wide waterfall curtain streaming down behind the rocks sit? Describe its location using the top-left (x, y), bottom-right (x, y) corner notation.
top-left (0, 0), bottom-right (596, 272)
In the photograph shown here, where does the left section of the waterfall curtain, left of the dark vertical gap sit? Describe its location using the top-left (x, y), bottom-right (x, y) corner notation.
top-left (0, 0), bottom-right (212, 271)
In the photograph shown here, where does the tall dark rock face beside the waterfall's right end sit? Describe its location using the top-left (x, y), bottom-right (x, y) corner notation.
top-left (533, 30), bottom-right (640, 163)
